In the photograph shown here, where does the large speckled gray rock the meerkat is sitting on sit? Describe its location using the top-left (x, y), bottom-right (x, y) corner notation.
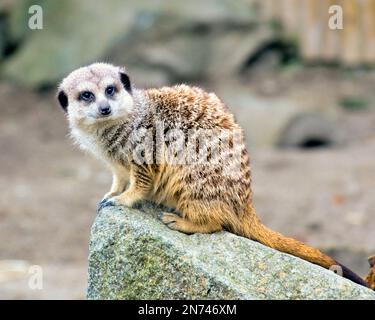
top-left (87, 203), bottom-right (375, 299)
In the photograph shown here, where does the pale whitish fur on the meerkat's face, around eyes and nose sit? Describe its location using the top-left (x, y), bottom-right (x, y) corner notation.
top-left (59, 63), bottom-right (134, 130)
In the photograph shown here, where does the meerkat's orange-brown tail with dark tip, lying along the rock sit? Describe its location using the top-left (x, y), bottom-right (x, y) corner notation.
top-left (243, 206), bottom-right (368, 287)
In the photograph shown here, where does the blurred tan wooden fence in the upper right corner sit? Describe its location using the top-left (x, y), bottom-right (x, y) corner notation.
top-left (257, 0), bottom-right (375, 65)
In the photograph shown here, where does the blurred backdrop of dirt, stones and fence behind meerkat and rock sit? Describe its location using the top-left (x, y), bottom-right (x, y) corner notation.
top-left (0, 0), bottom-right (375, 299)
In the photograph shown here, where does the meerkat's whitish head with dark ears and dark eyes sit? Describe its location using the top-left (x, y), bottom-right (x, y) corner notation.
top-left (57, 63), bottom-right (133, 126)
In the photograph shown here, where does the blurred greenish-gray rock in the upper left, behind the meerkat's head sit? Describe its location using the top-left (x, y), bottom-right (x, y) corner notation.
top-left (2, 0), bottom-right (137, 88)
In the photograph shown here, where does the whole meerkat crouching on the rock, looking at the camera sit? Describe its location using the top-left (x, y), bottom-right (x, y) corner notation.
top-left (57, 63), bottom-right (367, 286)
